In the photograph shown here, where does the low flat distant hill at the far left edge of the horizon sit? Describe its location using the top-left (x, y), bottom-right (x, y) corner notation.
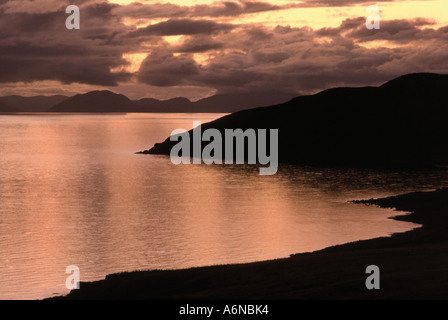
top-left (0, 95), bottom-right (68, 112)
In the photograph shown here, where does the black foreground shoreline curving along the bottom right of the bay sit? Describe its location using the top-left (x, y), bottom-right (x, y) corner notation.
top-left (50, 188), bottom-right (448, 300)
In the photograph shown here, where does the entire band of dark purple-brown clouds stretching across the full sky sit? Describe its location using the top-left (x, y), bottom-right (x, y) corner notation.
top-left (0, 0), bottom-right (448, 93)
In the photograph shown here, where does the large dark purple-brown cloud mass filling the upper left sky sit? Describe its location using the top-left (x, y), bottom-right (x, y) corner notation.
top-left (0, 0), bottom-right (132, 86)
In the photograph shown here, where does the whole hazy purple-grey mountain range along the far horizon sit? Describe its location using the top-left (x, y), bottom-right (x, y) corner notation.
top-left (0, 91), bottom-right (296, 113)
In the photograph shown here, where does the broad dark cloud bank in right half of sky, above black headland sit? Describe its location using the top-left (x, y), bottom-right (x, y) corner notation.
top-left (139, 18), bottom-right (448, 93)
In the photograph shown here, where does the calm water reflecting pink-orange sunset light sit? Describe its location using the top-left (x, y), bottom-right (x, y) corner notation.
top-left (0, 114), bottom-right (447, 299)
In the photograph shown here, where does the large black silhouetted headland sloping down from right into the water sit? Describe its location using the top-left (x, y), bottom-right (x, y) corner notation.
top-left (144, 74), bottom-right (448, 167)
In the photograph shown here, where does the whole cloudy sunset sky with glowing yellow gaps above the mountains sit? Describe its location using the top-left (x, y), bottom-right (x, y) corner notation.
top-left (0, 0), bottom-right (448, 100)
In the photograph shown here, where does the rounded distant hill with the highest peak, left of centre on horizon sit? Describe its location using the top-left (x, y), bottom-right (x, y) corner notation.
top-left (49, 90), bottom-right (132, 112)
